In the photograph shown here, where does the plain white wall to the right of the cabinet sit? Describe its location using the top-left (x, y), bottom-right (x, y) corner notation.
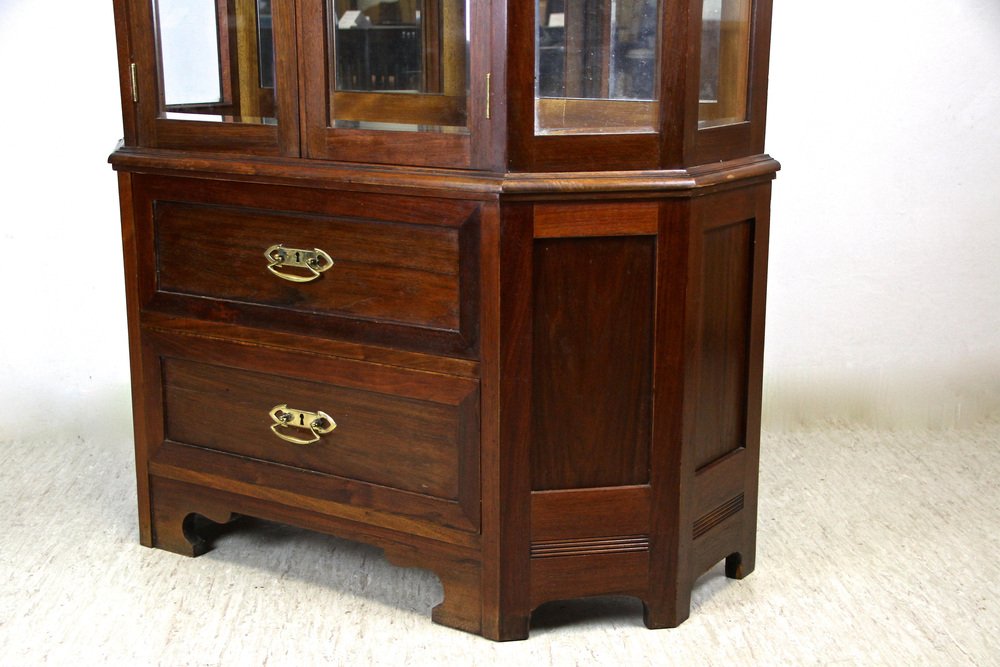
top-left (765, 0), bottom-right (1000, 426)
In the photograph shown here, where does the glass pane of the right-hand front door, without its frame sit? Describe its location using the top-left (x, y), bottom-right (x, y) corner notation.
top-left (328, 0), bottom-right (469, 132)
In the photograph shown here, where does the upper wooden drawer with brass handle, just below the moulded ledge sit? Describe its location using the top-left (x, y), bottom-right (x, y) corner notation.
top-left (136, 178), bottom-right (479, 356)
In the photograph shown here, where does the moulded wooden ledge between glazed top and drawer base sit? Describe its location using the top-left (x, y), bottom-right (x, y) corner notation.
top-left (108, 143), bottom-right (781, 199)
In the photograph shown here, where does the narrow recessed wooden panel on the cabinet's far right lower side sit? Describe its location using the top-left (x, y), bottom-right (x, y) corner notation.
top-left (695, 220), bottom-right (753, 468)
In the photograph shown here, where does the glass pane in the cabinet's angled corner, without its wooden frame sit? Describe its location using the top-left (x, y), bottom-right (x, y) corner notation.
top-left (535, 0), bottom-right (660, 134)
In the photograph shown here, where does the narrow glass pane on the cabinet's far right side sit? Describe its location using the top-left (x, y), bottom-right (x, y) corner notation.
top-left (698, 0), bottom-right (750, 127)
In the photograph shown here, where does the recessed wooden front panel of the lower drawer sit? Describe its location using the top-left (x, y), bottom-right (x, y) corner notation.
top-left (163, 359), bottom-right (477, 500)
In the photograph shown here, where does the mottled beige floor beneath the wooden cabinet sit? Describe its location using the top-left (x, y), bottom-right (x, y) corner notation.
top-left (0, 423), bottom-right (1000, 667)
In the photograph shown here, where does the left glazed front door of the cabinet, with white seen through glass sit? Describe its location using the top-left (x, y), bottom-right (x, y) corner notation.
top-left (122, 0), bottom-right (299, 156)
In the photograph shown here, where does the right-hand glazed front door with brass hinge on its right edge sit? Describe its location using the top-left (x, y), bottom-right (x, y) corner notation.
top-left (299, 0), bottom-right (489, 168)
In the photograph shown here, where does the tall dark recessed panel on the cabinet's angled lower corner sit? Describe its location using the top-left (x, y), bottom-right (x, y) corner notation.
top-left (531, 236), bottom-right (656, 490)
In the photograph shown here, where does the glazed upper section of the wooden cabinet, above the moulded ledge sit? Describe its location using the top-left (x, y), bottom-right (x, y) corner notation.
top-left (114, 0), bottom-right (773, 174)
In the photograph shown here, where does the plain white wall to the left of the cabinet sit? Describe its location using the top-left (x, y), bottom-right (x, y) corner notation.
top-left (0, 5), bottom-right (131, 441)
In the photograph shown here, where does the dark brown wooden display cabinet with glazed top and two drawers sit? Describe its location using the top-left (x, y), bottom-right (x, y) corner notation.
top-left (111, 0), bottom-right (778, 639)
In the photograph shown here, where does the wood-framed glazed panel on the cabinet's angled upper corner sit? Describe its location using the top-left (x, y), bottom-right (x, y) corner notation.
top-left (507, 0), bottom-right (680, 171)
